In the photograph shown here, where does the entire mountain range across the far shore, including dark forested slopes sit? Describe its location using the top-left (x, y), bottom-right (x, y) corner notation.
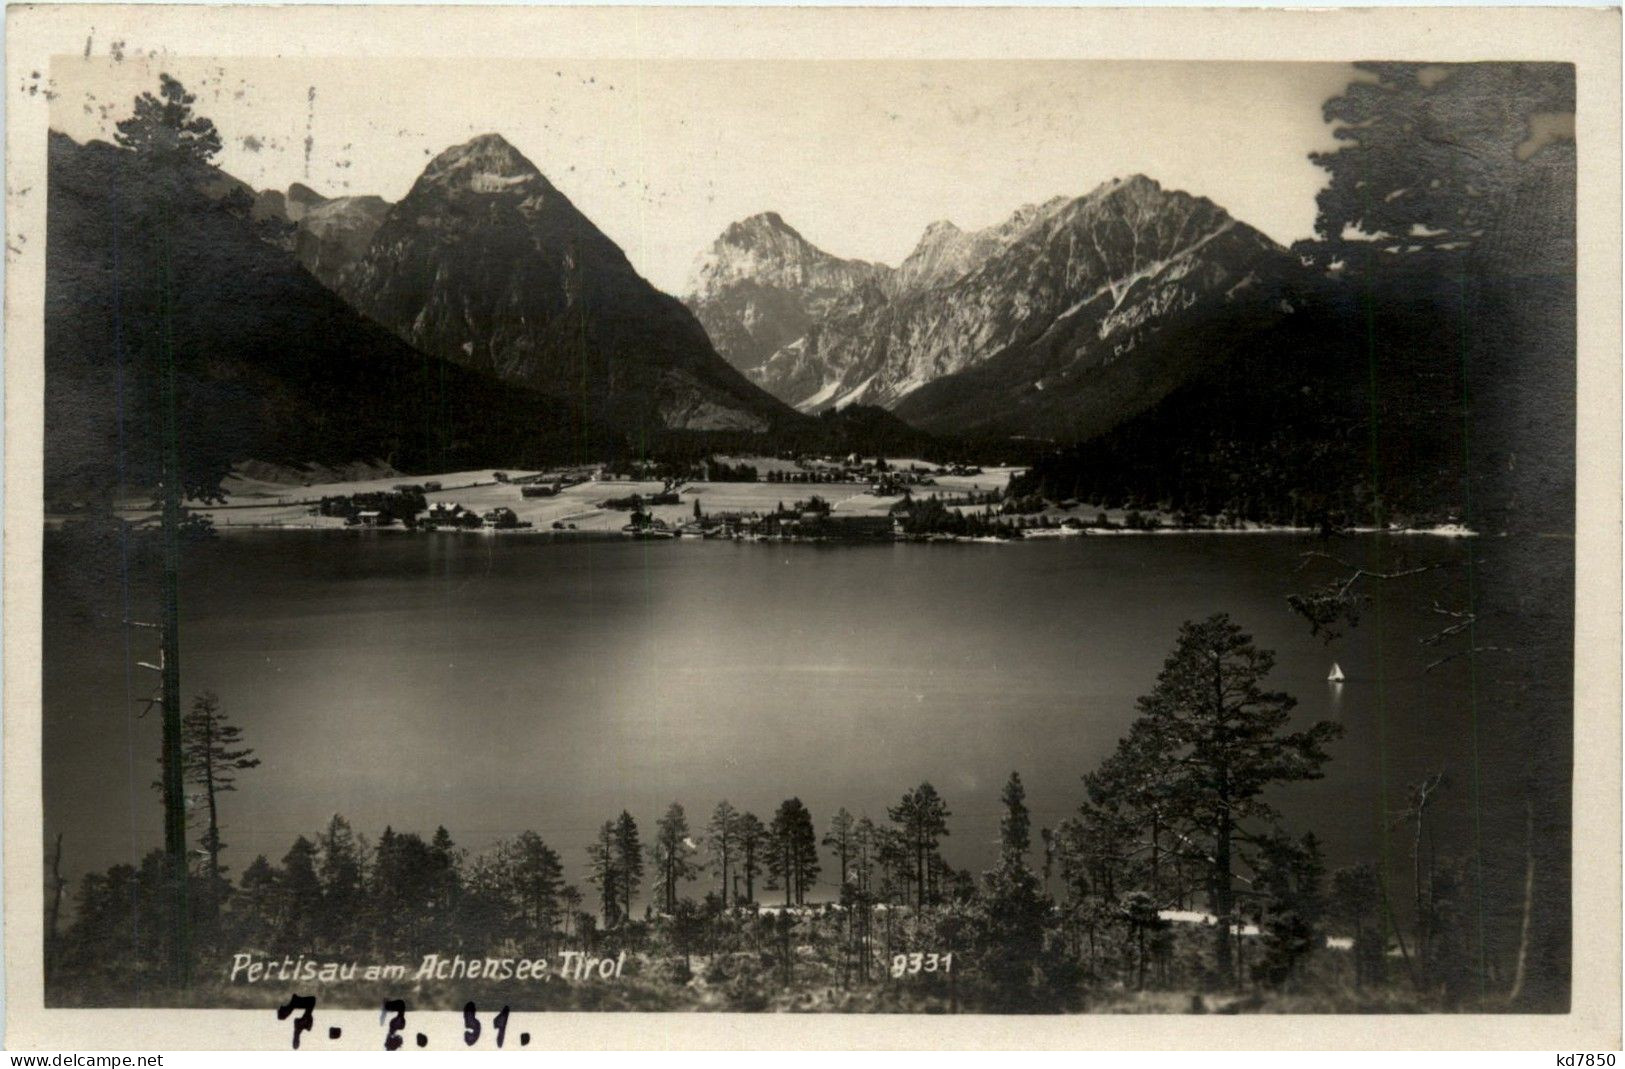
top-left (46, 119), bottom-right (1528, 515)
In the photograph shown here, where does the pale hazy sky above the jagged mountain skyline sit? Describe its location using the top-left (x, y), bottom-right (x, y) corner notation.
top-left (50, 55), bottom-right (1354, 292)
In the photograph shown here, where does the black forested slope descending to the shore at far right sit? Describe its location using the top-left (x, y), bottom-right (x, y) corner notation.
top-left (1014, 265), bottom-right (1573, 531)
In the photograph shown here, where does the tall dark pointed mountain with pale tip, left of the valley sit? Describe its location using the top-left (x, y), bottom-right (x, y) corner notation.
top-left (340, 133), bottom-right (790, 431)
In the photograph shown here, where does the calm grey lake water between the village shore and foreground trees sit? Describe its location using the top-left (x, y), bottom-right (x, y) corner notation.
top-left (44, 531), bottom-right (1571, 935)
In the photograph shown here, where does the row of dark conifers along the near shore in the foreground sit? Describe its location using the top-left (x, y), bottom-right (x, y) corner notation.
top-left (47, 614), bottom-right (1514, 1011)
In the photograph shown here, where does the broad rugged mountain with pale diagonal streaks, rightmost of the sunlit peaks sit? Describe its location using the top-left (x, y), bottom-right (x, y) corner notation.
top-left (895, 175), bottom-right (1300, 440)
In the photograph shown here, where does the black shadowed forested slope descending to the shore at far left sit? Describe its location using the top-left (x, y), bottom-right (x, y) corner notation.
top-left (46, 133), bottom-right (621, 497)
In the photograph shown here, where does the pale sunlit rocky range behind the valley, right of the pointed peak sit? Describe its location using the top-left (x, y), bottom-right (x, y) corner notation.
top-left (687, 175), bottom-right (1302, 440)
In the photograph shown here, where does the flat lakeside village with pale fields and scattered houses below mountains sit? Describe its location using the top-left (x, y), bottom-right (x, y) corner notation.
top-left (292, 455), bottom-right (1215, 541)
